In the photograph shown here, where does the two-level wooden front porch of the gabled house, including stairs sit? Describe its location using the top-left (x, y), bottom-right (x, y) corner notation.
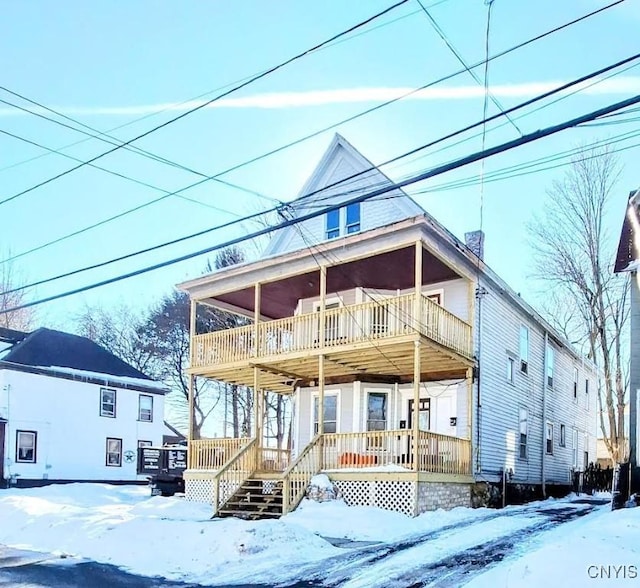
top-left (181, 217), bottom-right (475, 516)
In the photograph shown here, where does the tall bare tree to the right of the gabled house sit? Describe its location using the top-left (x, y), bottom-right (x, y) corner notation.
top-left (530, 149), bottom-right (629, 463)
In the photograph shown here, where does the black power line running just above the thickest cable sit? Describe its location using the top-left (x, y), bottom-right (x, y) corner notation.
top-left (0, 53), bottom-right (640, 294)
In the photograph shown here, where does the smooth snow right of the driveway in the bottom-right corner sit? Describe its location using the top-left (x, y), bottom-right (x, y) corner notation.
top-left (465, 500), bottom-right (640, 588)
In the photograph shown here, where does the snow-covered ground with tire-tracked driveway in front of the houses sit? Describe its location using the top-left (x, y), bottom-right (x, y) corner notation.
top-left (0, 484), bottom-right (640, 588)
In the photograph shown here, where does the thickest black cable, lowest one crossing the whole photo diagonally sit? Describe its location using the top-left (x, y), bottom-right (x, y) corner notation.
top-left (0, 94), bottom-right (640, 314)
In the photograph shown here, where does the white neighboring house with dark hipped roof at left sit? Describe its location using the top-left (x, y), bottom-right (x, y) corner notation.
top-left (0, 329), bottom-right (167, 486)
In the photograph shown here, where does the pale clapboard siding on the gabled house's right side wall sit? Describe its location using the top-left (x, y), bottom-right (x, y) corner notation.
top-left (476, 284), bottom-right (596, 484)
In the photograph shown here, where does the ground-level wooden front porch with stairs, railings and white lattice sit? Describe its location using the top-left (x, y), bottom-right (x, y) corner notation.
top-left (185, 429), bottom-right (472, 516)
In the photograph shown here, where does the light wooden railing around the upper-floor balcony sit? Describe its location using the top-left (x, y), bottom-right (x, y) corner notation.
top-left (191, 294), bottom-right (473, 368)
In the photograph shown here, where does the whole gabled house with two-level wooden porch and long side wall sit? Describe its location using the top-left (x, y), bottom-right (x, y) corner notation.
top-left (180, 135), bottom-right (596, 517)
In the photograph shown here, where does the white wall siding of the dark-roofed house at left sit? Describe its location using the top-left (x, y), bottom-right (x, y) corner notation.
top-left (0, 370), bottom-right (164, 481)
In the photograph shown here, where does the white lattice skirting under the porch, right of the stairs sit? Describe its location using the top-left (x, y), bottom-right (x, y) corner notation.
top-left (333, 480), bottom-right (416, 516)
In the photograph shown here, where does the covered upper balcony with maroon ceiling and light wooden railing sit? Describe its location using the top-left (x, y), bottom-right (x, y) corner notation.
top-left (182, 217), bottom-right (474, 392)
